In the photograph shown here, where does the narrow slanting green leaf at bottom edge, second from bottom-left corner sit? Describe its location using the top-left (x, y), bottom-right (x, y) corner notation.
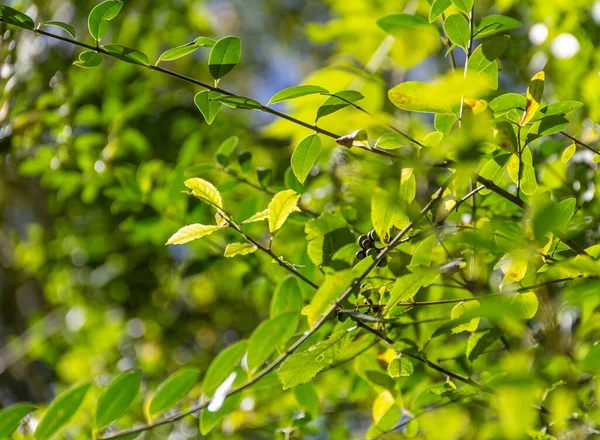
top-left (35, 383), bottom-right (91, 440)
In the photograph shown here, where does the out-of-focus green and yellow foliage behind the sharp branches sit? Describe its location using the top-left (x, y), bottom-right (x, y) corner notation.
top-left (0, 0), bottom-right (600, 439)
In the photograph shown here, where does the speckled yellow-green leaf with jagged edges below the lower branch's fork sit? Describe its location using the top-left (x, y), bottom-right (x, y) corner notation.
top-left (277, 327), bottom-right (356, 390)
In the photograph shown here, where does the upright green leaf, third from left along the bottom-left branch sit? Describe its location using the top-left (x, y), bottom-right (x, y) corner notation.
top-left (94, 370), bottom-right (142, 429)
